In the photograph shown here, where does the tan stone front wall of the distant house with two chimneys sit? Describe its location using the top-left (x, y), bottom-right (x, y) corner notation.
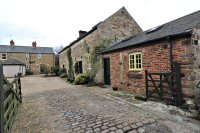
top-left (7, 53), bottom-right (55, 74)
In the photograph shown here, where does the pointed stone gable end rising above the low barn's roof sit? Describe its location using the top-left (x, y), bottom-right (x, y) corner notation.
top-left (98, 7), bottom-right (142, 42)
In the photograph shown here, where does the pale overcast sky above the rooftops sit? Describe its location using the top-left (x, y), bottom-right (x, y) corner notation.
top-left (0, 0), bottom-right (200, 47)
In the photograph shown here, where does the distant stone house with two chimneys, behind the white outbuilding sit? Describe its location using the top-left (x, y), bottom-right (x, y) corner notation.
top-left (0, 40), bottom-right (55, 74)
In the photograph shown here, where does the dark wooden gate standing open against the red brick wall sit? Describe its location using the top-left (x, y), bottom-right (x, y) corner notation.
top-left (145, 63), bottom-right (183, 106)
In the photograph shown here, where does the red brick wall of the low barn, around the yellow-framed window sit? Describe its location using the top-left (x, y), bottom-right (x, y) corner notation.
top-left (103, 38), bottom-right (193, 95)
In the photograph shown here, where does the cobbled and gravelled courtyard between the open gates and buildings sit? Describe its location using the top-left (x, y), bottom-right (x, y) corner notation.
top-left (11, 76), bottom-right (200, 133)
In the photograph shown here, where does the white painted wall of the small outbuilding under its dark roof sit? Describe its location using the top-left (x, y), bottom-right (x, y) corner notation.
top-left (3, 65), bottom-right (26, 77)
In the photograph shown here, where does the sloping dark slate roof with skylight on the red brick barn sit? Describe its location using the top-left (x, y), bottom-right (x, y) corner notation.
top-left (102, 10), bottom-right (200, 53)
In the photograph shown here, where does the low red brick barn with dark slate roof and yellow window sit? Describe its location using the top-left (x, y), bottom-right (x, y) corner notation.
top-left (102, 11), bottom-right (200, 105)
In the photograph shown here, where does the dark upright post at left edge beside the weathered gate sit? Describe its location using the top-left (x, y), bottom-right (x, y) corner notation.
top-left (0, 64), bottom-right (5, 133)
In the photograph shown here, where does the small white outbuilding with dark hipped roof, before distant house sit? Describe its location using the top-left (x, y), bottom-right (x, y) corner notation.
top-left (3, 59), bottom-right (26, 77)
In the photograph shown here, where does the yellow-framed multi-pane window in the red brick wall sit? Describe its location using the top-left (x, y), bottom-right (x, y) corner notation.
top-left (129, 53), bottom-right (142, 70)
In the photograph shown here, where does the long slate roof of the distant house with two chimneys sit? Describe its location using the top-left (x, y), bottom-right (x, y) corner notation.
top-left (0, 45), bottom-right (54, 54)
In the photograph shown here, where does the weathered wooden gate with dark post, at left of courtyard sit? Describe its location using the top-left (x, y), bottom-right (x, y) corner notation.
top-left (0, 64), bottom-right (22, 133)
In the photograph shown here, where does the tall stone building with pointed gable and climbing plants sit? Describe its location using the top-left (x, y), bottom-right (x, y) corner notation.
top-left (59, 7), bottom-right (142, 82)
